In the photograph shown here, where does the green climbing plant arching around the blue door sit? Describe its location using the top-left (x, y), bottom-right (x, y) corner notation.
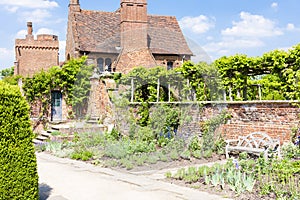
top-left (23, 56), bottom-right (93, 119)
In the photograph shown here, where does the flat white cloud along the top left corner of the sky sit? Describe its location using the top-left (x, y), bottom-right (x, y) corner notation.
top-left (0, 0), bottom-right (58, 9)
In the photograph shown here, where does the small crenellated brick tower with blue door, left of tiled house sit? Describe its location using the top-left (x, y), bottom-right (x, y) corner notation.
top-left (14, 22), bottom-right (66, 120)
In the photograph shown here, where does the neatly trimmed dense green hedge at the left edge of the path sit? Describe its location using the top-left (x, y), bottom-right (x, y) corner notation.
top-left (0, 81), bottom-right (38, 200)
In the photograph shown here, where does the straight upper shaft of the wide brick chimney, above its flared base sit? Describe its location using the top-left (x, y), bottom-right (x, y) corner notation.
top-left (121, 0), bottom-right (148, 51)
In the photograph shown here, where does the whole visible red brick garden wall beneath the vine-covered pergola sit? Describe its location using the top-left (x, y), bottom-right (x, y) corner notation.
top-left (175, 101), bottom-right (300, 143)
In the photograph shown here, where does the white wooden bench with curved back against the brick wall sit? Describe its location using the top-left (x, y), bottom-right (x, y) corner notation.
top-left (225, 132), bottom-right (280, 159)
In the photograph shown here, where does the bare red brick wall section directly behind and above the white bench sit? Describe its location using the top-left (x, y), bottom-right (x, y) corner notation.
top-left (218, 102), bottom-right (300, 142)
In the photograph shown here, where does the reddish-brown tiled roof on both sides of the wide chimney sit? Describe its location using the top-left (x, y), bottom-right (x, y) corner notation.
top-left (73, 10), bottom-right (192, 55)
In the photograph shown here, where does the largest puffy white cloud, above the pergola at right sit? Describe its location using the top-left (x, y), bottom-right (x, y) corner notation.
top-left (222, 12), bottom-right (283, 38)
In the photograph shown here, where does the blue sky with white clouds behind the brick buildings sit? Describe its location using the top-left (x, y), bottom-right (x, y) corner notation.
top-left (0, 0), bottom-right (300, 69)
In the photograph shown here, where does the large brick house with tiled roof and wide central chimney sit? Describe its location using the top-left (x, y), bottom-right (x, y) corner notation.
top-left (66, 0), bottom-right (193, 73)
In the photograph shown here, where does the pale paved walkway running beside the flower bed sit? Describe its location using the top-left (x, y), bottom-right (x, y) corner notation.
top-left (37, 153), bottom-right (228, 200)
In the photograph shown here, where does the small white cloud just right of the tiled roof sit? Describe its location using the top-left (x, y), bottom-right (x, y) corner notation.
top-left (179, 15), bottom-right (215, 34)
